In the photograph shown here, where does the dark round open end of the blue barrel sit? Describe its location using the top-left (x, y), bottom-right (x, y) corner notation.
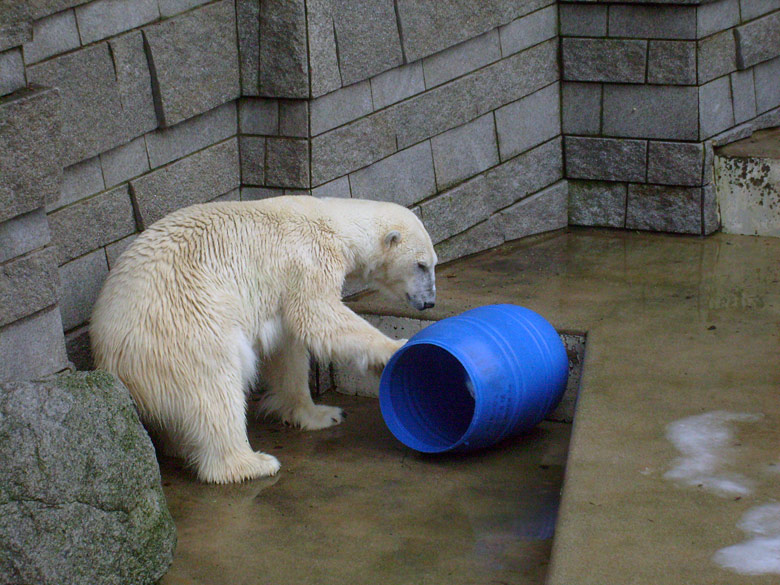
top-left (389, 343), bottom-right (475, 453)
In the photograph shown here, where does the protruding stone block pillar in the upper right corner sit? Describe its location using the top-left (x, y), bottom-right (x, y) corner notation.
top-left (560, 0), bottom-right (780, 234)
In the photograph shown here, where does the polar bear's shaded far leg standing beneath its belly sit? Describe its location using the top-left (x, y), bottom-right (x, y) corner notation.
top-left (260, 337), bottom-right (344, 431)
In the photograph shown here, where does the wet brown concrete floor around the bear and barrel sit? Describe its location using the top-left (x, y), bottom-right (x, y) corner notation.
top-left (162, 229), bottom-right (780, 585)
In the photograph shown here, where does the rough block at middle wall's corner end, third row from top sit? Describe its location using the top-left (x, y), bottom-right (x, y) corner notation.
top-left (311, 110), bottom-right (396, 187)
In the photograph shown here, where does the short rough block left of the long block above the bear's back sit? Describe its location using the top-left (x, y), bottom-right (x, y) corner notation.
top-left (49, 185), bottom-right (135, 264)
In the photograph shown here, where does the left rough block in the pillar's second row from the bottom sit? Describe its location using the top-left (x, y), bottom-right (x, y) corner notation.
top-left (564, 136), bottom-right (647, 182)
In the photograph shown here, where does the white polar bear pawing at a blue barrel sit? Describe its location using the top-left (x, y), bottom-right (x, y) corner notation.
top-left (90, 196), bottom-right (437, 483)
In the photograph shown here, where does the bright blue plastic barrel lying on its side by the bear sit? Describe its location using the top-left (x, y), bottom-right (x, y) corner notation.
top-left (379, 305), bottom-right (569, 453)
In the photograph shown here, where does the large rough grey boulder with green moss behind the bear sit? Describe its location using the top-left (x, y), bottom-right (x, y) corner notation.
top-left (0, 372), bottom-right (176, 585)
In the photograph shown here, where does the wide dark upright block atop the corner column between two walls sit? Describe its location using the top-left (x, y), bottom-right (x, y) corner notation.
top-left (259, 0), bottom-right (309, 98)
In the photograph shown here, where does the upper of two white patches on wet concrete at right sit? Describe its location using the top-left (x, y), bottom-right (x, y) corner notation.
top-left (664, 411), bottom-right (761, 496)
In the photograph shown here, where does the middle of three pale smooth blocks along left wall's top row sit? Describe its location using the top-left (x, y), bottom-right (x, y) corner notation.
top-left (76, 0), bottom-right (160, 45)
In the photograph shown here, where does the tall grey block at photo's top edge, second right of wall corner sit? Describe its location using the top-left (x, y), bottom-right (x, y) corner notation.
top-left (333, 0), bottom-right (404, 85)
